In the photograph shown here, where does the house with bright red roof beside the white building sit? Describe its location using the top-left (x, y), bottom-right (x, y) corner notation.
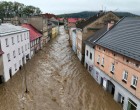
top-left (22, 24), bottom-right (42, 56)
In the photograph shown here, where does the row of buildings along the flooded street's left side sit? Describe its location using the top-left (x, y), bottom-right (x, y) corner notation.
top-left (0, 14), bottom-right (59, 83)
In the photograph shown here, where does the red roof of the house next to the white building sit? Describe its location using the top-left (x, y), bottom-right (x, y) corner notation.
top-left (21, 24), bottom-right (42, 41)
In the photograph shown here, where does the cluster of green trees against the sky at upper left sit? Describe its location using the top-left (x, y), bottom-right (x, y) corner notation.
top-left (0, 1), bottom-right (42, 19)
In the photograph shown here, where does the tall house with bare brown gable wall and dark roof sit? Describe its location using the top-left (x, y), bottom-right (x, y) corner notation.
top-left (76, 12), bottom-right (119, 63)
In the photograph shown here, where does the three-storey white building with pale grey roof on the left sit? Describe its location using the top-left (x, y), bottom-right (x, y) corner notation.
top-left (0, 24), bottom-right (30, 82)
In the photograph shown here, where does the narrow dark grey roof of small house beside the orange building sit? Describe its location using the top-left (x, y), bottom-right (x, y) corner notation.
top-left (85, 25), bottom-right (107, 47)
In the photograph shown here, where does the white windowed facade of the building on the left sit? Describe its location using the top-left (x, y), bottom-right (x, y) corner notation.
top-left (0, 31), bottom-right (30, 82)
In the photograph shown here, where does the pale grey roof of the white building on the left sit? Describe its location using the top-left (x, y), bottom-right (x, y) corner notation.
top-left (0, 23), bottom-right (28, 36)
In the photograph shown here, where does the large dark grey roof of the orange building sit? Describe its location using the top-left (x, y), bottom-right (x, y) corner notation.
top-left (97, 17), bottom-right (140, 61)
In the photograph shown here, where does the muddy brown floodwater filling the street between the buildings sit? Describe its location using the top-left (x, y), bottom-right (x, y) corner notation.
top-left (0, 27), bottom-right (121, 110)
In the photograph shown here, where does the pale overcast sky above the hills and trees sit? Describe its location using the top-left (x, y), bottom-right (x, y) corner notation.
top-left (3, 0), bottom-right (140, 15)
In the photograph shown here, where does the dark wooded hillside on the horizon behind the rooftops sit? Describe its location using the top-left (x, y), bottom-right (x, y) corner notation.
top-left (58, 11), bottom-right (138, 18)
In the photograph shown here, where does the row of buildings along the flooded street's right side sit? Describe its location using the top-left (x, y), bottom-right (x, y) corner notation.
top-left (69, 12), bottom-right (140, 110)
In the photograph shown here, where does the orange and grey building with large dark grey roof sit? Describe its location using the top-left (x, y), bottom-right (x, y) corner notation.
top-left (93, 17), bottom-right (140, 110)
